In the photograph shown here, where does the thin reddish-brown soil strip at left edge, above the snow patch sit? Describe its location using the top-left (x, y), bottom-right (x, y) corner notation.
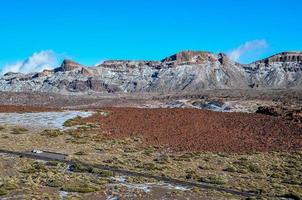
top-left (0, 105), bottom-right (61, 113)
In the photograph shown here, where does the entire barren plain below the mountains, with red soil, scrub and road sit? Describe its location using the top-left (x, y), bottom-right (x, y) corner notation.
top-left (0, 90), bottom-right (302, 199)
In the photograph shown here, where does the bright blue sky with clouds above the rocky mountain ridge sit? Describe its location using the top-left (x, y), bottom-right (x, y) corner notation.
top-left (0, 0), bottom-right (302, 73)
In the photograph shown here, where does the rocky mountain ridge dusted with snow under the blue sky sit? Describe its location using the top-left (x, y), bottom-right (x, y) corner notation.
top-left (0, 51), bottom-right (302, 94)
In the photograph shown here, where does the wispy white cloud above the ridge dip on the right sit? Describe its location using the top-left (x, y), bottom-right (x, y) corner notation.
top-left (227, 40), bottom-right (268, 61)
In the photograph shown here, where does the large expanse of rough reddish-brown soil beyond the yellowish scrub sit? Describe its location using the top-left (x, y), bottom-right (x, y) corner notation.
top-left (85, 108), bottom-right (302, 153)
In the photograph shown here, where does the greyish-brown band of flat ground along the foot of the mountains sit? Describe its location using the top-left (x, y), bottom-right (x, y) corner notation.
top-left (0, 89), bottom-right (302, 109)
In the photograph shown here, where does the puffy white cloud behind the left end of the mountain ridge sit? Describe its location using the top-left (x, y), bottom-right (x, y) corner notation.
top-left (1, 50), bottom-right (58, 74)
